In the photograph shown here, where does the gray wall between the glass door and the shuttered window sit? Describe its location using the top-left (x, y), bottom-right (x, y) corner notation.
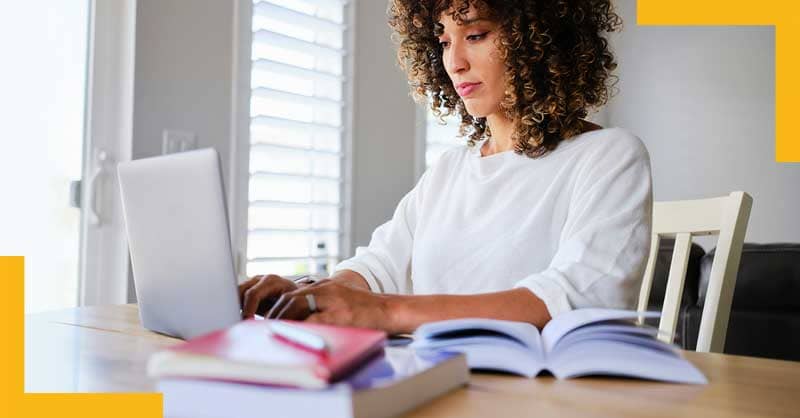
top-left (133, 0), bottom-right (234, 190)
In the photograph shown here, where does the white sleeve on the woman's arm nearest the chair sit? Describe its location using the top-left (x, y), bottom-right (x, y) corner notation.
top-left (514, 136), bottom-right (652, 317)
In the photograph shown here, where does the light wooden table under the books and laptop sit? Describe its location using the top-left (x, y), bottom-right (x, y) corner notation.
top-left (25, 305), bottom-right (800, 418)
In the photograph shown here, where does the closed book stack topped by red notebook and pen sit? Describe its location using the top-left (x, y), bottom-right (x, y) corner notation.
top-left (148, 320), bottom-right (469, 418)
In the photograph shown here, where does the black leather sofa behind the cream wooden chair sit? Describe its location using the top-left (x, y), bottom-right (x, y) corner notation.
top-left (648, 240), bottom-right (800, 361)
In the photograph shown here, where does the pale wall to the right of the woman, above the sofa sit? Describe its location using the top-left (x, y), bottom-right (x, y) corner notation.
top-left (607, 0), bottom-right (800, 247)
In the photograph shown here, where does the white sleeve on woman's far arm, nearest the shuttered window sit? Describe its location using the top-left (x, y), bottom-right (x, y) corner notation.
top-left (334, 172), bottom-right (428, 293)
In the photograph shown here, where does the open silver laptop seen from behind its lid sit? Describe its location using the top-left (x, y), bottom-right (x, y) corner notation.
top-left (118, 149), bottom-right (241, 339)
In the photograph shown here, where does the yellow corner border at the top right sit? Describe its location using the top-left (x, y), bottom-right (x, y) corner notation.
top-left (640, 0), bottom-right (800, 162)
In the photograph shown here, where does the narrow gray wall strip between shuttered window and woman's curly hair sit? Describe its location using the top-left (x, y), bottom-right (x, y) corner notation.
top-left (352, 0), bottom-right (416, 250)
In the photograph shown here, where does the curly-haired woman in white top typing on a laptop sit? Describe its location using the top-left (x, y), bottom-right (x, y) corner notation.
top-left (239, 0), bottom-right (652, 333)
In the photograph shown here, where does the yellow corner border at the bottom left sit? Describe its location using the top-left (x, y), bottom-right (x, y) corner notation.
top-left (0, 256), bottom-right (162, 418)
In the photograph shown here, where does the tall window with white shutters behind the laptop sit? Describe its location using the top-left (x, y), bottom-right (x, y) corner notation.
top-left (247, 0), bottom-right (350, 276)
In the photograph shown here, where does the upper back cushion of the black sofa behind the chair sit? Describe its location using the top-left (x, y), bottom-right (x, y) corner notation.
top-left (698, 243), bottom-right (800, 315)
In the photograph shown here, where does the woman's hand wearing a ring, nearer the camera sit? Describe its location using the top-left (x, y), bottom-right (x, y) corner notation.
top-left (265, 279), bottom-right (393, 333)
